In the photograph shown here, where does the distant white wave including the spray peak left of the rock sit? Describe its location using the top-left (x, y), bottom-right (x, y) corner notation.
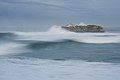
top-left (0, 26), bottom-right (120, 44)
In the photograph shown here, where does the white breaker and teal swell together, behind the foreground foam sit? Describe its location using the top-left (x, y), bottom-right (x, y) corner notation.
top-left (0, 26), bottom-right (120, 62)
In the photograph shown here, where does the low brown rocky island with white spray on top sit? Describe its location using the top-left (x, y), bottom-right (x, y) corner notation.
top-left (62, 23), bottom-right (105, 33)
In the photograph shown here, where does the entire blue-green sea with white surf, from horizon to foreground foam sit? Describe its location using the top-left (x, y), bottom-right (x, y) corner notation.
top-left (0, 26), bottom-right (120, 80)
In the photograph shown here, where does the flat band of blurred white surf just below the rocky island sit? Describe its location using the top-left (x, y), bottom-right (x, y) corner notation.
top-left (17, 33), bottom-right (120, 44)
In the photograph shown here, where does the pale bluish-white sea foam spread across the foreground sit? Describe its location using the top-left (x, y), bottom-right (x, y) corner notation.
top-left (0, 59), bottom-right (120, 80)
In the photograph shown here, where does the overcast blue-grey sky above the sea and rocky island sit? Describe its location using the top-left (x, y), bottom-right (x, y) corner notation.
top-left (0, 0), bottom-right (120, 31)
